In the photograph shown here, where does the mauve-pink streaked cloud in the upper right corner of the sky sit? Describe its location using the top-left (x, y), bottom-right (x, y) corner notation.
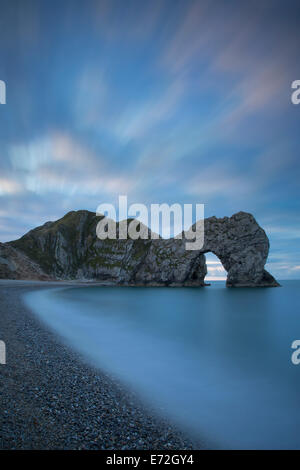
top-left (161, 0), bottom-right (298, 141)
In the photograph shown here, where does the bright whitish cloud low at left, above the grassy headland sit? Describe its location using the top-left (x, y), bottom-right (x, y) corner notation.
top-left (8, 133), bottom-right (133, 195)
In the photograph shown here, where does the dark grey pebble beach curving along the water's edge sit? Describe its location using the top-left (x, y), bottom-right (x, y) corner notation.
top-left (0, 280), bottom-right (206, 450)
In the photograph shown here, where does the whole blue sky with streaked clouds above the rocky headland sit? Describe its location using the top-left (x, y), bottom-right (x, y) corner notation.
top-left (0, 0), bottom-right (300, 279)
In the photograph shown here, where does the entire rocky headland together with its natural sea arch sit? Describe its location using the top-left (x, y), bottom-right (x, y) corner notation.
top-left (0, 211), bottom-right (278, 287)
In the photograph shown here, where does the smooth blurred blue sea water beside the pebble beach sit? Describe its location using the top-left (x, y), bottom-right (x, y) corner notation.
top-left (25, 281), bottom-right (300, 449)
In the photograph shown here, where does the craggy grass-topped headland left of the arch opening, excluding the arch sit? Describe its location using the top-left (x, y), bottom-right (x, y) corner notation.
top-left (9, 211), bottom-right (206, 286)
